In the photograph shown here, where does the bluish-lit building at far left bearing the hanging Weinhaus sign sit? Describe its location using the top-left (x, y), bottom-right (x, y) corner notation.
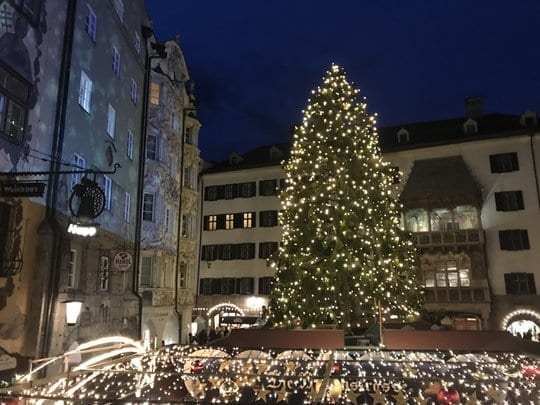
top-left (0, 0), bottom-right (149, 376)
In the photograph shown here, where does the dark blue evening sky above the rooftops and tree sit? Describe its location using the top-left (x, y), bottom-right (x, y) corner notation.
top-left (146, 0), bottom-right (540, 160)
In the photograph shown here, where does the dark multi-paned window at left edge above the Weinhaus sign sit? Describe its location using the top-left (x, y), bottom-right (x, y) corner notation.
top-left (0, 68), bottom-right (28, 144)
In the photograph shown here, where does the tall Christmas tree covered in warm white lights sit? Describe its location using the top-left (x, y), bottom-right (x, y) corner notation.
top-left (271, 65), bottom-right (422, 330)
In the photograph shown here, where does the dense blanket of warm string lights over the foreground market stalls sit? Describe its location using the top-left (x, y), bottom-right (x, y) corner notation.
top-left (2, 336), bottom-right (540, 404)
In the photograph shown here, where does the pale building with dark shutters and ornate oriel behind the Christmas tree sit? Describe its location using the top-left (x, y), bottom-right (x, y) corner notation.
top-left (197, 99), bottom-right (540, 335)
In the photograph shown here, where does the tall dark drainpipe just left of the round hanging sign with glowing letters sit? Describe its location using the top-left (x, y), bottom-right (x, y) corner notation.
top-left (37, 0), bottom-right (77, 357)
